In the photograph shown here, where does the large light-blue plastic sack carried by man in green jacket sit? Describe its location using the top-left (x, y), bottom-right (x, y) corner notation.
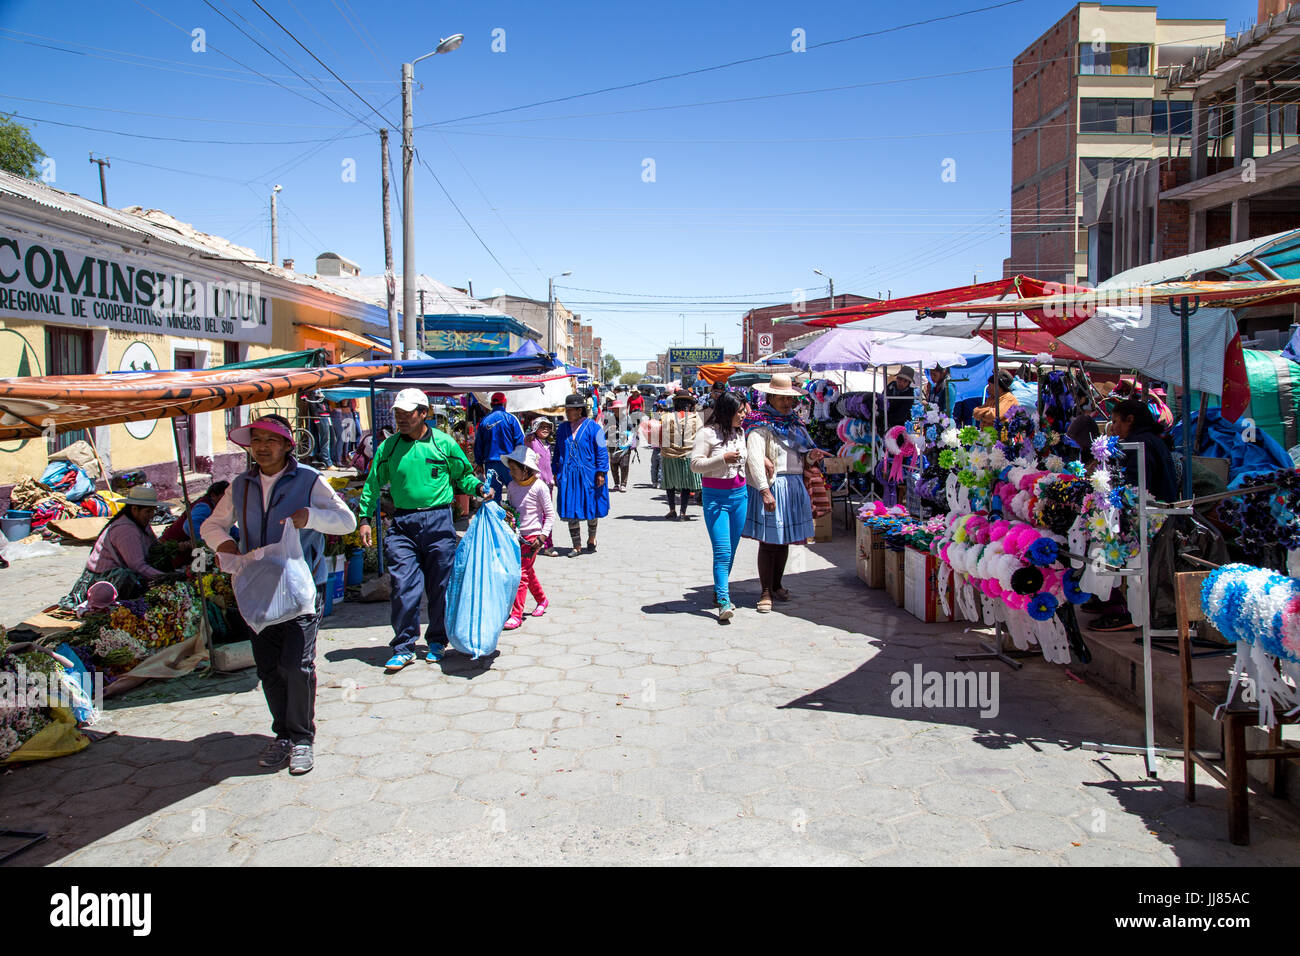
top-left (445, 501), bottom-right (521, 658)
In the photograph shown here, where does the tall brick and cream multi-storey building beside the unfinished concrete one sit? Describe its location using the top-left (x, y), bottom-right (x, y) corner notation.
top-left (1002, 3), bottom-right (1223, 284)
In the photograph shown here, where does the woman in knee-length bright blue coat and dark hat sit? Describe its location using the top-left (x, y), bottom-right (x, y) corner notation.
top-left (551, 394), bottom-right (610, 558)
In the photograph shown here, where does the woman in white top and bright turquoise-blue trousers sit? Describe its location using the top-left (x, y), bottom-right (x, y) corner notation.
top-left (690, 393), bottom-right (749, 623)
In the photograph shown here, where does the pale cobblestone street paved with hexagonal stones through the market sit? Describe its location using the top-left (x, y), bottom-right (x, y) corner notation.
top-left (0, 462), bottom-right (1300, 866)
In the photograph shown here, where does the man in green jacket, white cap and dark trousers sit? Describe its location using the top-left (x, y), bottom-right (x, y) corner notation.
top-left (360, 389), bottom-right (486, 674)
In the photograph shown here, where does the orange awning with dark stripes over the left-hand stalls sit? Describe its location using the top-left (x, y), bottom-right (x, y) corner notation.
top-left (0, 363), bottom-right (393, 440)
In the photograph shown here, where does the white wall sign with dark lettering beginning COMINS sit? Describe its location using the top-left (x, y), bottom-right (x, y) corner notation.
top-left (0, 233), bottom-right (270, 343)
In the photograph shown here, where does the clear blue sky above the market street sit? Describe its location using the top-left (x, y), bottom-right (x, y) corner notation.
top-left (0, 0), bottom-right (1256, 369)
